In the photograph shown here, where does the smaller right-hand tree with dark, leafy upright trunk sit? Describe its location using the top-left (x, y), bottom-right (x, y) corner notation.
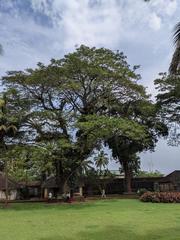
top-left (79, 99), bottom-right (167, 192)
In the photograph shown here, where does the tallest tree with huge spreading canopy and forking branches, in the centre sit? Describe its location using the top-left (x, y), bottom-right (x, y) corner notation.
top-left (3, 46), bottom-right (165, 194)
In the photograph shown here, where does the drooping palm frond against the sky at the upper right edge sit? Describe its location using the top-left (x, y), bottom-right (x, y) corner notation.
top-left (169, 22), bottom-right (180, 74)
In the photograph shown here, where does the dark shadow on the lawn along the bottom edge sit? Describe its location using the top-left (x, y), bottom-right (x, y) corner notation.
top-left (38, 225), bottom-right (180, 240)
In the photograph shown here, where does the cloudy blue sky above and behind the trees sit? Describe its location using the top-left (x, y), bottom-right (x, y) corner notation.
top-left (0, 0), bottom-right (180, 174)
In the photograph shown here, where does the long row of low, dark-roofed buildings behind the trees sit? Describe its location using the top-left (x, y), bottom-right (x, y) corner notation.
top-left (0, 170), bottom-right (180, 200)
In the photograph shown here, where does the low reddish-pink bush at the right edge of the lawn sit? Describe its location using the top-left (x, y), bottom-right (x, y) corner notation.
top-left (140, 192), bottom-right (180, 203)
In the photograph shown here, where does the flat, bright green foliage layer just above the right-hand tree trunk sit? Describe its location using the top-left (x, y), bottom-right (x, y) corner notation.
top-left (77, 115), bottom-right (147, 142)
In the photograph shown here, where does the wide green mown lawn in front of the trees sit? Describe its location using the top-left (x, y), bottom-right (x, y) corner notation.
top-left (0, 200), bottom-right (180, 240)
